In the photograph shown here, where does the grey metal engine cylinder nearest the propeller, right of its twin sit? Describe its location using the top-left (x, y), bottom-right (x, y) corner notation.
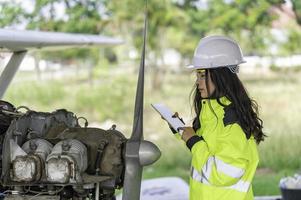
top-left (46, 139), bottom-right (88, 183)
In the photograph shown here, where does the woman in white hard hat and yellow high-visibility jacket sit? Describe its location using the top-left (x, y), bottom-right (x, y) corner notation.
top-left (173, 36), bottom-right (265, 200)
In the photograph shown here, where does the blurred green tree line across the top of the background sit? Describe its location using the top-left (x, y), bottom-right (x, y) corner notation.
top-left (0, 0), bottom-right (292, 80)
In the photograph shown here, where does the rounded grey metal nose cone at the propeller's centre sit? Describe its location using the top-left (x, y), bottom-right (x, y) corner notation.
top-left (139, 140), bottom-right (161, 166)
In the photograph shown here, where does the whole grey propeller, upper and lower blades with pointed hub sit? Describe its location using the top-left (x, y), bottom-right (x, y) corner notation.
top-left (122, 0), bottom-right (161, 200)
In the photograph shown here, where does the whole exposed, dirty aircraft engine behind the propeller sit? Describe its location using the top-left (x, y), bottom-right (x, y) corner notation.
top-left (0, 109), bottom-right (127, 200)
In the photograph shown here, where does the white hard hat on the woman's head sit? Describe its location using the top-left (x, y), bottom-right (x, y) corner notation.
top-left (188, 36), bottom-right (246, 73)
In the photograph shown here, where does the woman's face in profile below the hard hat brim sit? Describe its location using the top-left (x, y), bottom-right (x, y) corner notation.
top-left (196, 69), bottom-right (215, 98)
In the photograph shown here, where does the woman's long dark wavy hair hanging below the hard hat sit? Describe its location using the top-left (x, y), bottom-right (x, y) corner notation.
top-left (193, 67), bottom-right (266, 144)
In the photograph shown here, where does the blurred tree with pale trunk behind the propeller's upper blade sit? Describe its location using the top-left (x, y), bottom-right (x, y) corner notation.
top-left (107, 0), bottom-right (188, 89)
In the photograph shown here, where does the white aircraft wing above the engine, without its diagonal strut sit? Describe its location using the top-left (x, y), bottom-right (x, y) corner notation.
top-left (0, 29), bottom-right (123, 52)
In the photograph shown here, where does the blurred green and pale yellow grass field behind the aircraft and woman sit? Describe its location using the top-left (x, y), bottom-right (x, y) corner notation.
top-left (4, 68), bottom-right (301, 195)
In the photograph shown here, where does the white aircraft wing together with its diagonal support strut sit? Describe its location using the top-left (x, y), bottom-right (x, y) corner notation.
top-left (0, 29), bottom-right (123, 98)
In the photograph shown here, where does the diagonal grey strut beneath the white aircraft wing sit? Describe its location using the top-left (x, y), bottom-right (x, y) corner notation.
top-left (0, 51), bottom-right (27, 99)
